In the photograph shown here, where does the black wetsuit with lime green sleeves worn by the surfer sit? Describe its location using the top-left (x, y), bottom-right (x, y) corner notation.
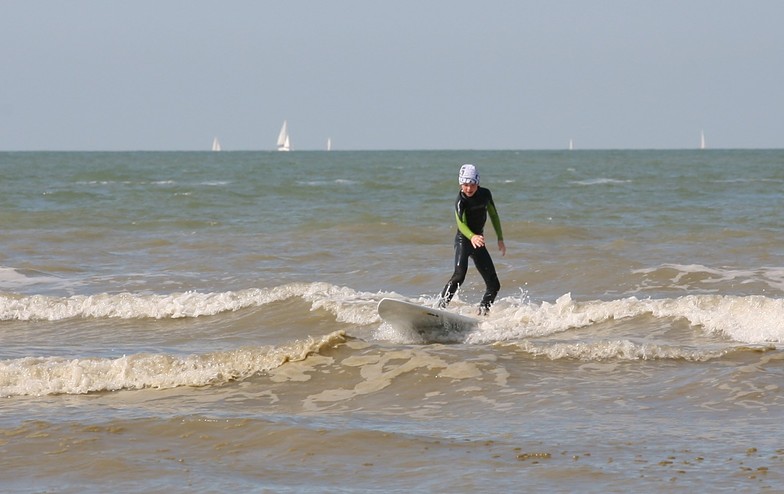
top-left (439, 187), bottom-right (504, 309)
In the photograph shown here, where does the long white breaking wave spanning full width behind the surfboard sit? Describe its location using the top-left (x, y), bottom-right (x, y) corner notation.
top-left (0, 282), bottom-right (784, 350)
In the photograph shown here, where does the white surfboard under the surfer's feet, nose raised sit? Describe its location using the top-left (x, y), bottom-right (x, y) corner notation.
top-left (378, 298), bottom-right (479, 335)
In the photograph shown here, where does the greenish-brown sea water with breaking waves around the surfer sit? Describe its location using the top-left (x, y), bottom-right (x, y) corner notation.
top-left (0, 150), bottom-right (784, 492)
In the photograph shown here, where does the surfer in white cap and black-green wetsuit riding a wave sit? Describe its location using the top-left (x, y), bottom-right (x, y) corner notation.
top-left (438, 164), bottom-right (506, 315)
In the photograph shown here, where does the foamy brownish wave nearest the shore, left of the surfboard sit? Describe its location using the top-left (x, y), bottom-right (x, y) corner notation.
top-left (0, 331), bottom-right (346, 397)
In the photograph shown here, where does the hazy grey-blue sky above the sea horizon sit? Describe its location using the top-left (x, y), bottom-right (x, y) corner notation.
top-left (0, 0), bottom-right (784, 150)
